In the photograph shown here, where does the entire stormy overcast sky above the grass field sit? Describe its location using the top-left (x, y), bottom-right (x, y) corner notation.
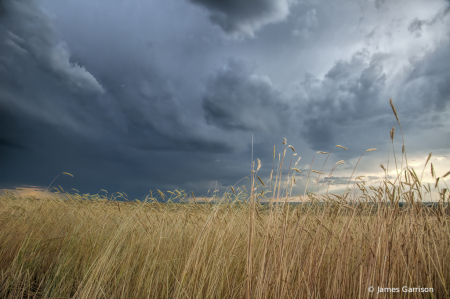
top-left (0, 0), bottom-right (450, 199)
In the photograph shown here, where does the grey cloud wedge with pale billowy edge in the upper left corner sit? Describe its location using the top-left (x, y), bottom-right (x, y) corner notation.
top-left (0, 1), bottom-right (104, 93)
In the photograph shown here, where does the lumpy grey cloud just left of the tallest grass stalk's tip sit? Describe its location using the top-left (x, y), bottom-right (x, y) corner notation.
top-left (297, 50), bottom-right (387, 150)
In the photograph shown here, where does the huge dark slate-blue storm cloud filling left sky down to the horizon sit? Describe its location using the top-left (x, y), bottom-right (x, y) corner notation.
top-left (0, 1), bottom-right (241, 196)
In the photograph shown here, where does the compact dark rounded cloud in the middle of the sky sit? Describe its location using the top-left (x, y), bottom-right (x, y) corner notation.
top-left (202, 59), bottom-right (289, 133)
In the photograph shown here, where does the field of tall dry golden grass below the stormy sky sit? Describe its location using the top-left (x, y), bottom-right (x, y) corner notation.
top-left (0, 100), bottom-right (450, 298)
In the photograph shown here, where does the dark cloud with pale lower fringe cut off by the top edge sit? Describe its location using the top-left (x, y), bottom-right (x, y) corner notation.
top-left (186, 0), bottom-right (292, 37)
